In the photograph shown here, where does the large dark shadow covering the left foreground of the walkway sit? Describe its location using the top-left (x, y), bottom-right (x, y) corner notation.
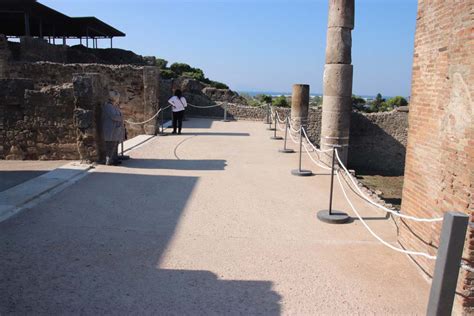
top-left (0, 172), bottom-right (280, 315)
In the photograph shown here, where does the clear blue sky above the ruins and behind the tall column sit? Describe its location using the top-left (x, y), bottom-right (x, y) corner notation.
top-left (39, 0), bottom-right (417, 96)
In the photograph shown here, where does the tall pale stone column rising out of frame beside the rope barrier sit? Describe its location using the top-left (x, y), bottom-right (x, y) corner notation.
top-left (320, 0), bottom-right (354, 164)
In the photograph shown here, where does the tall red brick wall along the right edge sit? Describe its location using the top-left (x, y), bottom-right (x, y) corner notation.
top-left (399, 0), bottom-right (474, 312)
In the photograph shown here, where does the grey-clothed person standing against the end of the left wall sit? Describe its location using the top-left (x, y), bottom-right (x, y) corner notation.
top-left (102, 90), bottom-right (124, 166)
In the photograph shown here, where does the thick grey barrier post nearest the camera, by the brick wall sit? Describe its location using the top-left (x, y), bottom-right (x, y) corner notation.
top-left (426, 212), bottom-right (469, 316)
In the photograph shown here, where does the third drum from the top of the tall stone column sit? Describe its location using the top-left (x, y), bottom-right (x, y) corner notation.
top-left (323, 64), bottom-right (352, 100)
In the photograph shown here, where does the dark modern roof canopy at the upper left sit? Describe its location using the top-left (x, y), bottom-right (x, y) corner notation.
top-left (0, 0), bottom-right (125, 39)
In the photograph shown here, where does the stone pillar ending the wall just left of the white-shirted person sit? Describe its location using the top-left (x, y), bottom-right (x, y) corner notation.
top-left (143, 66), bottom-right (160, 135)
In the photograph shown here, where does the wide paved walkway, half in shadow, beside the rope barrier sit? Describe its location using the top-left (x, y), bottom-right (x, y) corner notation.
top-left (0, 119), bottom-right (429, 315)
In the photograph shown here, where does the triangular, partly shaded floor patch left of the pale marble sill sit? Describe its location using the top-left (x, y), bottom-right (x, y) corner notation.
top-left (0, 160), bottom-right (68, 192)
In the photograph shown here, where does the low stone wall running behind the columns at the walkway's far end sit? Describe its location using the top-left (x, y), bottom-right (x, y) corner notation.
top-left (186, 103), bottom-right (408, 175)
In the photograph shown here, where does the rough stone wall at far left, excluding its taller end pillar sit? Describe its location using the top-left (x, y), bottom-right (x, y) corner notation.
top-left (0, 79), bottom-right (78, 159)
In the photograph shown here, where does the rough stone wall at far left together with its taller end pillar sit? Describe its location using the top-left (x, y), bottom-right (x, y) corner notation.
top-left (0, 74), bottom-right (108, 161)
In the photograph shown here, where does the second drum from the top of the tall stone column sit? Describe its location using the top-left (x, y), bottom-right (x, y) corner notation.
top-left (326, 27), bottom-right (352, 64)
